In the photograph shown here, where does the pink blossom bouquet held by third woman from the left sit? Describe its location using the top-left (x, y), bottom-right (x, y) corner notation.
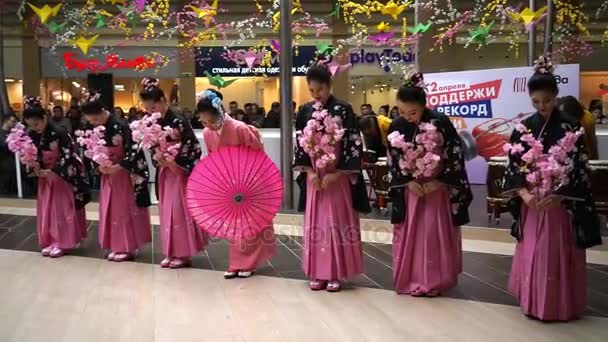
top-left (130, 113), bottom-right (181, 161)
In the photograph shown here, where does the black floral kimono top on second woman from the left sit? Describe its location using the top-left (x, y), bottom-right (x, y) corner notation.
top-left (104, 115), bottom-right (151, 207)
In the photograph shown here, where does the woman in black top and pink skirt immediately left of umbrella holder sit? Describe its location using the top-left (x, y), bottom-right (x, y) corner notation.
top-left (139, 77), bottom-right (208, 268)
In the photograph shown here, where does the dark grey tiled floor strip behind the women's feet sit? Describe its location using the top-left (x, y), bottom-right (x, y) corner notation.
top-left (0, 215), bottom-right (608, 317)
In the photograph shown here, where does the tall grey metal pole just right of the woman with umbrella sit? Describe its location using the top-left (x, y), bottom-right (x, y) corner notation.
top-left (279, 0), bottom-right (293, 209)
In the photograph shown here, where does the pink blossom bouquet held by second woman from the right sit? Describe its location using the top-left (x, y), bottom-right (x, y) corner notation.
top-left (388, 122), bottom-right (444, 179)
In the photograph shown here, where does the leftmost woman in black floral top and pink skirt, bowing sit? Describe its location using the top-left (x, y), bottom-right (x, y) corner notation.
top-left (23, 97), bottom-right (90, 258)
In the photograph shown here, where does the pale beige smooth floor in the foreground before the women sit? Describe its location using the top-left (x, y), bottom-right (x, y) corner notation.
top-left (0, 250), bottom-right (608, 342)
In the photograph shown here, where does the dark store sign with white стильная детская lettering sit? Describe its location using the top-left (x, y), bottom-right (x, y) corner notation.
top-left (195, 46), bottom-right (316, 77)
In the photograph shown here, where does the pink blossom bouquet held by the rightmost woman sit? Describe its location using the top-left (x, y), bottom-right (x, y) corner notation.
top-left (504, 124), bottom-right (584, 199)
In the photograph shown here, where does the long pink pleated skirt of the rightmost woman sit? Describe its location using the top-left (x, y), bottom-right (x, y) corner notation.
top-left (509, 206), bottom-right (586, 321)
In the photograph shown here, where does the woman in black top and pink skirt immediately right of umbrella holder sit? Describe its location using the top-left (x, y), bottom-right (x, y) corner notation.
top-left (294, 65), bottom-right (370, 292)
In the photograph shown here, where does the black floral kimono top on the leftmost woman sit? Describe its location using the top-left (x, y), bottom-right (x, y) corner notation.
top-left (28, 120), bottom-right (91, 209)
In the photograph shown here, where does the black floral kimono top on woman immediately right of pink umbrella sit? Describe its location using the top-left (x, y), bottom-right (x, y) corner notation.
top-left (293, 95), bottom-right (371, 213)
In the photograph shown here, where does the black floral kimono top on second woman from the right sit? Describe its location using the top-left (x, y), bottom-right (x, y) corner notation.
top-left (388, 109), bottom-right (473, 227)
